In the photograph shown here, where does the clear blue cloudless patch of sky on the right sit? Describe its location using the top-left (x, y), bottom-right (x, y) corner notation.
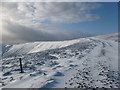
top-left (60, 2), bottom-right (118, 35)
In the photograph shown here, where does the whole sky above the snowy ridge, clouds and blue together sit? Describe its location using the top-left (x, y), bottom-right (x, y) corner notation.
top-left (0, 2), bottom-right (118, 44)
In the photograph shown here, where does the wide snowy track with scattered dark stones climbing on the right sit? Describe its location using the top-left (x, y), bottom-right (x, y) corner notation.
top-left (40, 39), bottom-right (119, 88)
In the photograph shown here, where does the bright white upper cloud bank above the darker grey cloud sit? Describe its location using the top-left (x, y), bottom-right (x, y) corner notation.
top-left (3, 2), bottom-right (101, 23)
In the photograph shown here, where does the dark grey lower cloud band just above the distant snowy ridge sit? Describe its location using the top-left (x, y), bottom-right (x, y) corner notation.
top-left (2, 22), bottom-right (91, 44)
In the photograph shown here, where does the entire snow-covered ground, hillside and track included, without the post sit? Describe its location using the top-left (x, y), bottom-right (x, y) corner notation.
top-left (0, 34), bottom-right (119, 88)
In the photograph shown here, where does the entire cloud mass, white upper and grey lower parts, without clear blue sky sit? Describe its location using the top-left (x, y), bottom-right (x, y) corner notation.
top-left (1, 2), bottom-right (101, 44)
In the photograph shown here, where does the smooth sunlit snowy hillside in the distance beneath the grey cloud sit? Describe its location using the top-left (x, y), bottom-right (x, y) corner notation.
top-left (3, 39), bottom-right (89, 57)
